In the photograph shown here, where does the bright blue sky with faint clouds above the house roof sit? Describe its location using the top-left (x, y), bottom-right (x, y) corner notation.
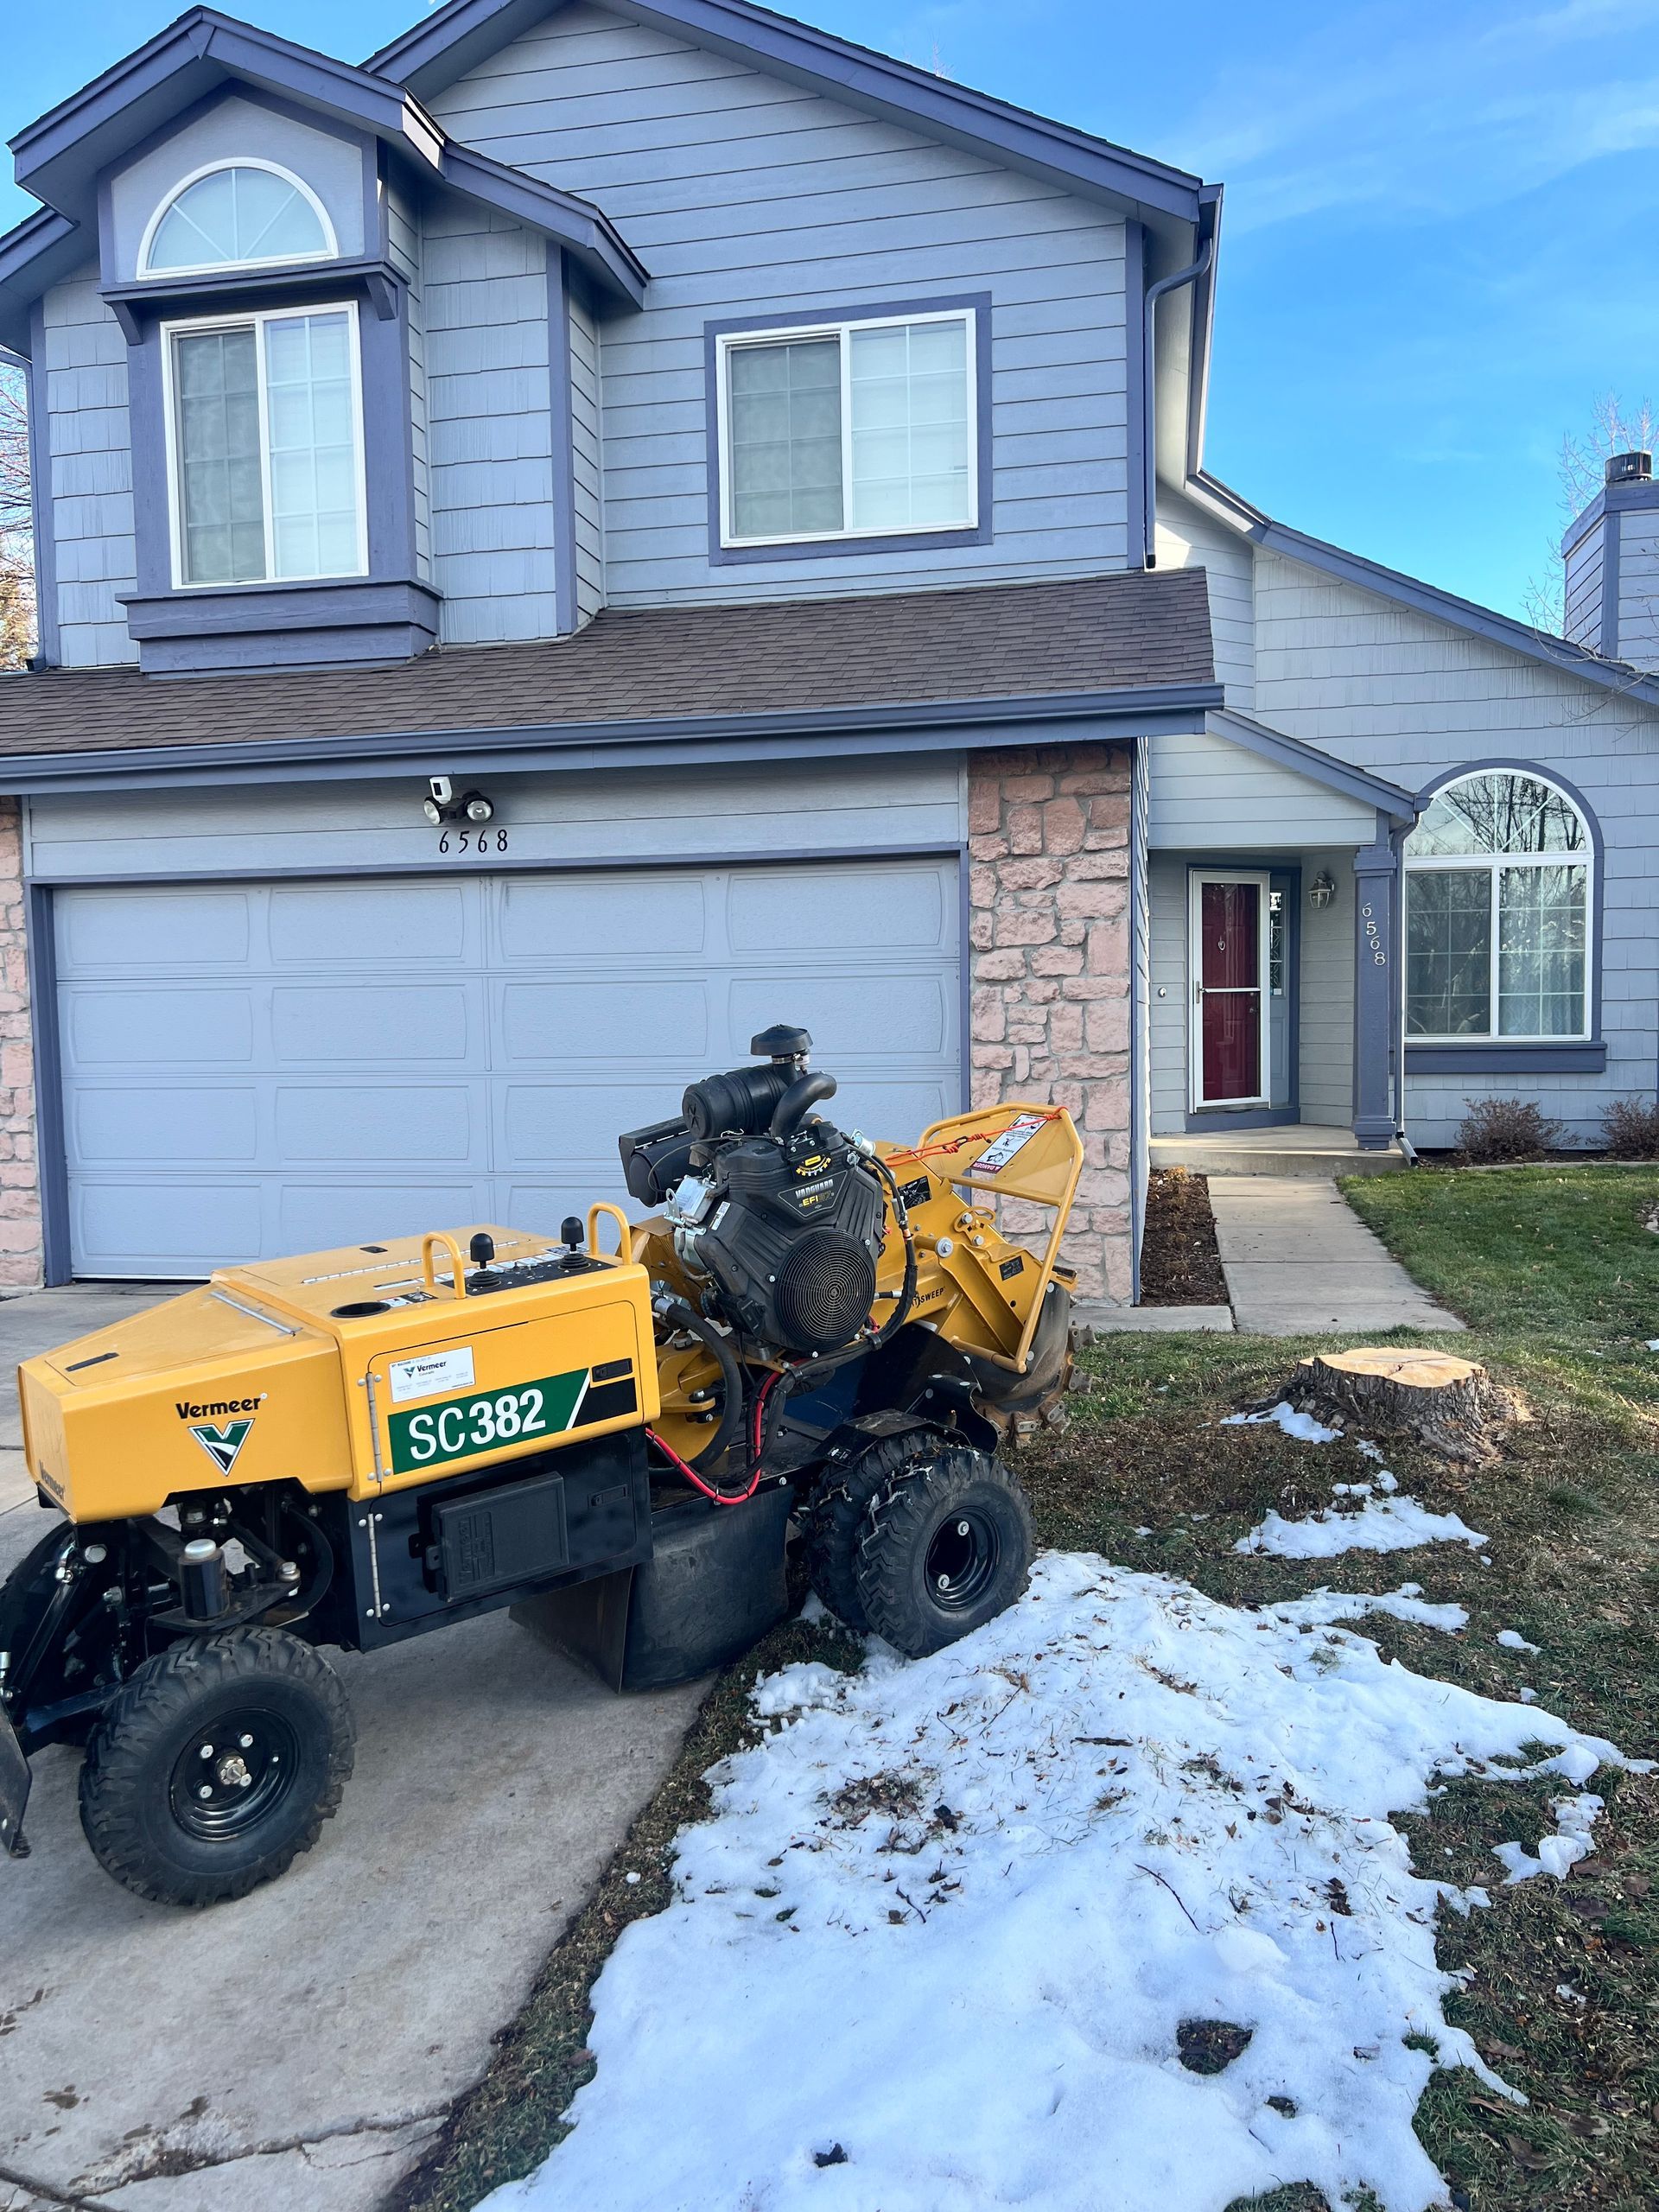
top-left (0, 0), bottom-right (1659, 613)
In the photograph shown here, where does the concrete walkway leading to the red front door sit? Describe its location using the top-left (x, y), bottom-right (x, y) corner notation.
top-left (1210, 1174), bottom-right (1462, 1336)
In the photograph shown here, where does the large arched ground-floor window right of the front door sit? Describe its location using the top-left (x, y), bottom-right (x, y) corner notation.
top-left (1405, 767), bottom-right (1595, 1039)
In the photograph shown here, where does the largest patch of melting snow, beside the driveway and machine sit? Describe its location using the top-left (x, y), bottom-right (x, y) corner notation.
top-left (489, 1553), bottom-right (1617, 2212)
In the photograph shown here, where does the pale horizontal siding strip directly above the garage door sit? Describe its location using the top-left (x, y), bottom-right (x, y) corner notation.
top-left (24, 752), bottom-right (964, 882)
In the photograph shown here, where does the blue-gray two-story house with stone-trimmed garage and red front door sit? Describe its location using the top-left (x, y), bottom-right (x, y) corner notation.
top-left (0, 0), bottom-right (1659, 1299)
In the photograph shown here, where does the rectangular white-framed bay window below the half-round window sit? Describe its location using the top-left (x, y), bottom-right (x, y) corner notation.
top-left (163, 303), bottom-right (370, 584)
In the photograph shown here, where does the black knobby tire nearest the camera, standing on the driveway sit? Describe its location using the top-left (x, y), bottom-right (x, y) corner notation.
top-left (79, 1628), bottom-right (356, 1904)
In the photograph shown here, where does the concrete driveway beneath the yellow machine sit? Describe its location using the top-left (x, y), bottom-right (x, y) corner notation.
top-left (0, 1289), bottom-right (702, 2212)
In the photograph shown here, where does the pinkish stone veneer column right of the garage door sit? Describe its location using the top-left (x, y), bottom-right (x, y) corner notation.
top-left (969, 746), bottom-right (1133, 1305)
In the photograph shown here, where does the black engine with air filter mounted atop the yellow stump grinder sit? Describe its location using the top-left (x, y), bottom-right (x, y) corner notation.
top-left (620, 1027), bottom-right (885, 1354)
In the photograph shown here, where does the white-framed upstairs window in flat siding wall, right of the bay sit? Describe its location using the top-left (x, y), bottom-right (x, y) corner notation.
top-left (719, 308), bottom-right (980, 546)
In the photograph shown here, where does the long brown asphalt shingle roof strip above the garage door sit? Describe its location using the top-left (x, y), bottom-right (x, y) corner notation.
top-left (0, 569), bottom-right (1212, 760)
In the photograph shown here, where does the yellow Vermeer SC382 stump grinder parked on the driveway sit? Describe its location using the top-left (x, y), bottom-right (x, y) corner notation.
top-left (0, 1027), bottom-right (1082, 1904)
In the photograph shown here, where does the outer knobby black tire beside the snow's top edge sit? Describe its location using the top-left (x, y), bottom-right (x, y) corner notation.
top-left (856, 1445), bottom-right (1031, 1659)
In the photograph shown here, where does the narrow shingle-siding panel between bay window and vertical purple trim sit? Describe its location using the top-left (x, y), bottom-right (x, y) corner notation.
top-left (423, 201), bottom-right (557, 646)
